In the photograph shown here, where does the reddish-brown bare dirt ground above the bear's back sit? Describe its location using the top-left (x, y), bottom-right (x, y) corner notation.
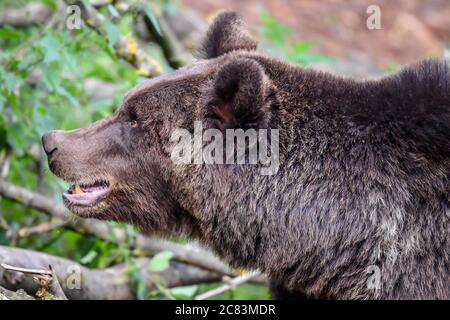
top-left (182, 0), bottom-right (450, 70)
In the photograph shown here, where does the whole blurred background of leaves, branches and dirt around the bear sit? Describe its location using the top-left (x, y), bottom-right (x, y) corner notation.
top-left (0, 0), bottom-right (450, 299)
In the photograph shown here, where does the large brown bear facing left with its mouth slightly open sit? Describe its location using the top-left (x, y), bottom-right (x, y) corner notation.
top-left (42, 12), bottom-right (450, 299)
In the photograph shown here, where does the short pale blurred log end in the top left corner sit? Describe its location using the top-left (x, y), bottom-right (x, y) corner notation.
top-left (0, 3), bottom-right (52, 28)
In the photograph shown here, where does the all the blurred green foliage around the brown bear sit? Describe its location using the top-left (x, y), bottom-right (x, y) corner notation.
top-left (0, 0), bottom-right (330, 299)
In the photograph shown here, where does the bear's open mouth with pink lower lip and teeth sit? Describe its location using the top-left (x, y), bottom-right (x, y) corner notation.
top-left (63, 180), bottom-right (111, 206)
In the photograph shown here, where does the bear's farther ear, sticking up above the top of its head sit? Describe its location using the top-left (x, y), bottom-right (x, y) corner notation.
top-left (199, 11), bottom-right (257, 59)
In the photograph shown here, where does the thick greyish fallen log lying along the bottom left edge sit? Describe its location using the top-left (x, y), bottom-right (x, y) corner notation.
top-left (0, 246), bottom-right (220, 300)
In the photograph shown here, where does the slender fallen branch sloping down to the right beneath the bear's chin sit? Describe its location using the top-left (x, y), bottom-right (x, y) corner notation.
top-left (0, 179), bottom-right (233, 275)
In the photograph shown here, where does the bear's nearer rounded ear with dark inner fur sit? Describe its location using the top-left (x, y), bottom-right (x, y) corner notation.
top-left (206, 58), bottom-right (273, 131)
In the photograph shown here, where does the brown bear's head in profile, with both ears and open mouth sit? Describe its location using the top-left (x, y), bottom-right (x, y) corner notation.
top-left (42, 12), bottom-right (277, 236)
